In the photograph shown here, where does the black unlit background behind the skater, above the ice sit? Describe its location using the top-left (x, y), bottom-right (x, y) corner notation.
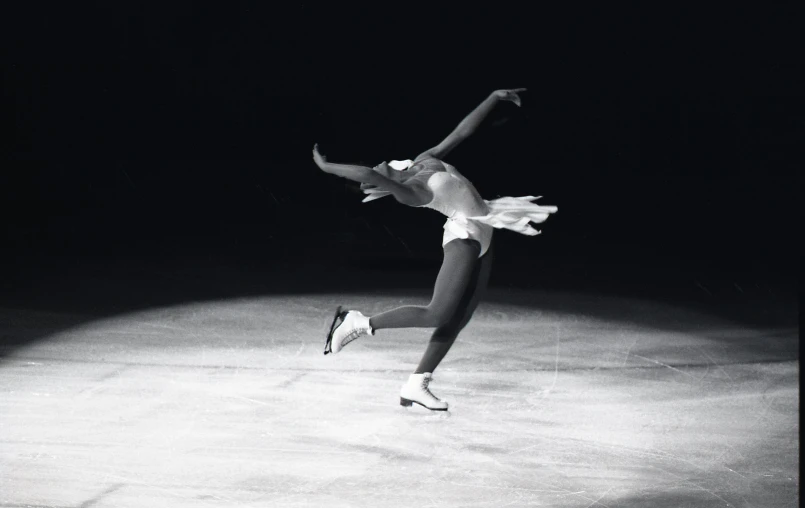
top-left (0, 1), bottom-right (805, 314)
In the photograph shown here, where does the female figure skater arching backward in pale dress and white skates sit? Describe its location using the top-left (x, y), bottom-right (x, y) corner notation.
top-left (313, 88), bottom-right (557, 411)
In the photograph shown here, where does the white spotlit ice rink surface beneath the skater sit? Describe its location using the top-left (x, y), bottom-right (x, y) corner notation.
top-left (0, 292), bottom-right (799, 508)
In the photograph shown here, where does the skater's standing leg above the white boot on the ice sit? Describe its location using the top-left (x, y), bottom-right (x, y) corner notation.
top-left (414, 242), bottom-right (492, 374)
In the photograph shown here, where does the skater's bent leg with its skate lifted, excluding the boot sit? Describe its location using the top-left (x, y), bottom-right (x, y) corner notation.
top-left (369, 240), bottom-right (486, 330)
